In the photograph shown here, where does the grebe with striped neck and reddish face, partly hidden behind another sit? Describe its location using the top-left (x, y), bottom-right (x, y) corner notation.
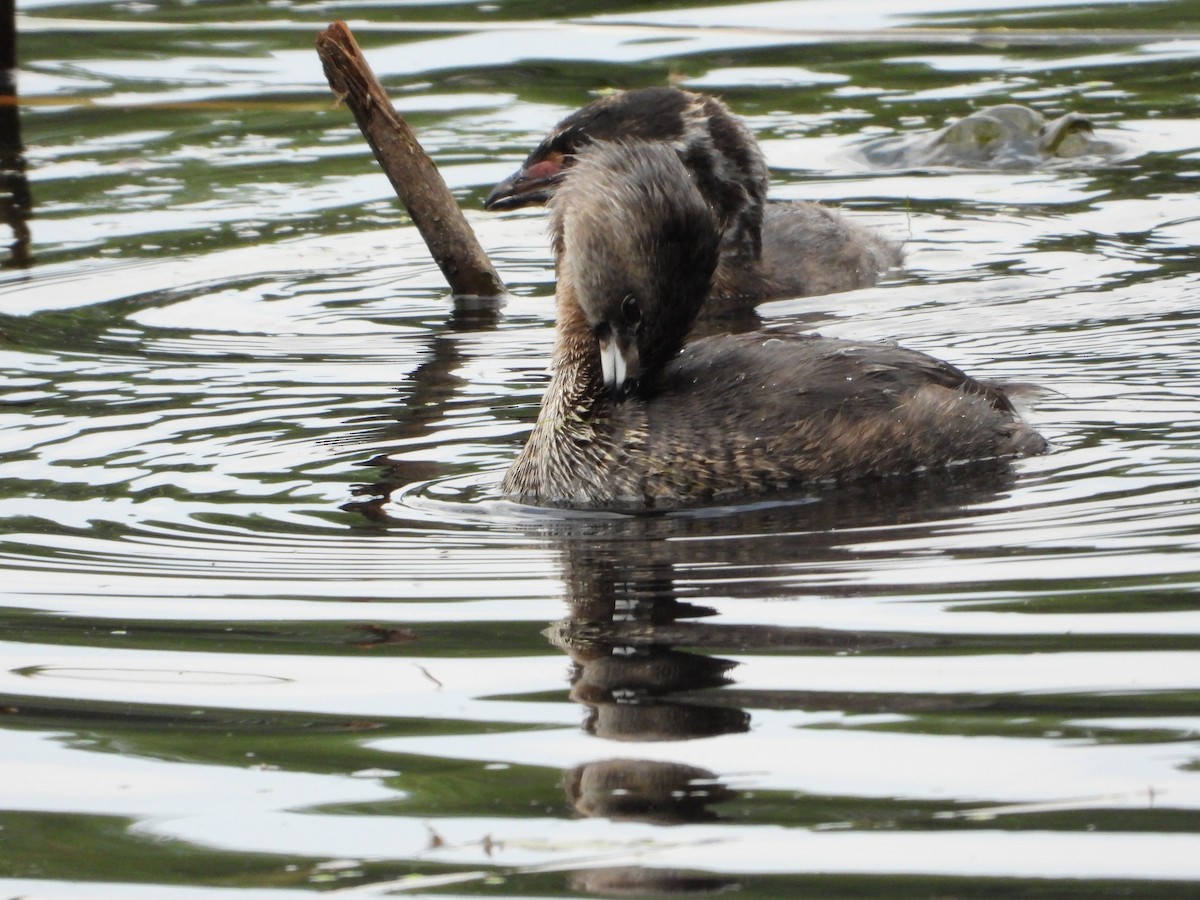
top-left (484, 88), bottom-right (900, 304)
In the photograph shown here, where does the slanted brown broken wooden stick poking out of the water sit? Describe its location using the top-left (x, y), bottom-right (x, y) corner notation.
top-left (317, 22), bottom-right (508, 298)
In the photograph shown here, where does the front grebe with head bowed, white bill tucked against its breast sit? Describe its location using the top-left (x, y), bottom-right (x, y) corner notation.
top-left (504, 143), bottom-right (1045, 508)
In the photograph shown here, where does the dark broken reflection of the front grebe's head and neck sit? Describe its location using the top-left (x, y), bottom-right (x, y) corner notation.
top-left (546, 547), bottom-right (750, 895)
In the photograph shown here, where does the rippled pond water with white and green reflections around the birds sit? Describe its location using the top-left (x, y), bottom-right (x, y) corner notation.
top-left (0, 0), bottom-right (1200, 898)
